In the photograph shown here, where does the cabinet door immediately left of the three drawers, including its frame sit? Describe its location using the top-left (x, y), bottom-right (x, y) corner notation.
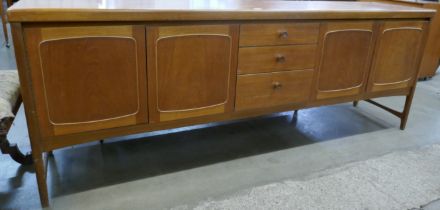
top-left (147, 25), bottom-right (238, 122)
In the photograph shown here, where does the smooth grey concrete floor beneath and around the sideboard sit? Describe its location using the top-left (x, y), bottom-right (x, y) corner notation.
top-left (0, 20), bottom-right (440, 209)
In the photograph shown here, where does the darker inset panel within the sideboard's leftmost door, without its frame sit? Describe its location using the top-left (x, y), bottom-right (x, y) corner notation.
top-left (40, 37), bottom-right (139, 125)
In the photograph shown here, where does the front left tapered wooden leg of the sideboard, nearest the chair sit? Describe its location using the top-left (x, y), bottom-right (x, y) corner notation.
top-left (33, 153), bottom-right (49, 208)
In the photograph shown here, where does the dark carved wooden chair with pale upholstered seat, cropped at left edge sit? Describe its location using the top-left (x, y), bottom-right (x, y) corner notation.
top-left (0, 70), bottom-right (33, 165)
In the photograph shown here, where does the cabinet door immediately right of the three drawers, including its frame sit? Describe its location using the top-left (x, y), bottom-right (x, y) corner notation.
top-left (316, 22), bottom-right (375, 99)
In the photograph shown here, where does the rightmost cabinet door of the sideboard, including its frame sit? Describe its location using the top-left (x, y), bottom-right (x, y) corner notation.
top-left (369, 21), bottom-right (426, 92)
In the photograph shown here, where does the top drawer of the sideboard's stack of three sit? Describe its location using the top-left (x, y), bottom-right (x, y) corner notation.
top-left (240, 23), bottom-right (319, 46)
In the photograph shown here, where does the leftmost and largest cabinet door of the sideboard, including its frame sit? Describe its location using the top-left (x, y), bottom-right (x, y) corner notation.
top-left (25, 26), bottom-right (148, 136)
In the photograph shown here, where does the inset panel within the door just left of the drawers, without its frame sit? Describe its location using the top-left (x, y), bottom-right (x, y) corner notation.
top-left (157, 35), bottom-right (230, 111)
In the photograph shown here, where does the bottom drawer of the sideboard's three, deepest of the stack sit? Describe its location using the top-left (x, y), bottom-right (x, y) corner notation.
top-left (235, 70), bottom-right (313, 110)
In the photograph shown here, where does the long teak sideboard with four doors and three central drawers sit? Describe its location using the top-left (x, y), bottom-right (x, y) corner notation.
top-left (8, 0), bottom-right (435, 206)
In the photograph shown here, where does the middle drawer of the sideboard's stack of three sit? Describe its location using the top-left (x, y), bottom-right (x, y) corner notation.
top-left (238, 45), bottom-right (316, 74)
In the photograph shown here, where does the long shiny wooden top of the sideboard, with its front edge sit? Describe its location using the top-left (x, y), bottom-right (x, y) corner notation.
top-left (8, 0), bottom-right (435, 22)
